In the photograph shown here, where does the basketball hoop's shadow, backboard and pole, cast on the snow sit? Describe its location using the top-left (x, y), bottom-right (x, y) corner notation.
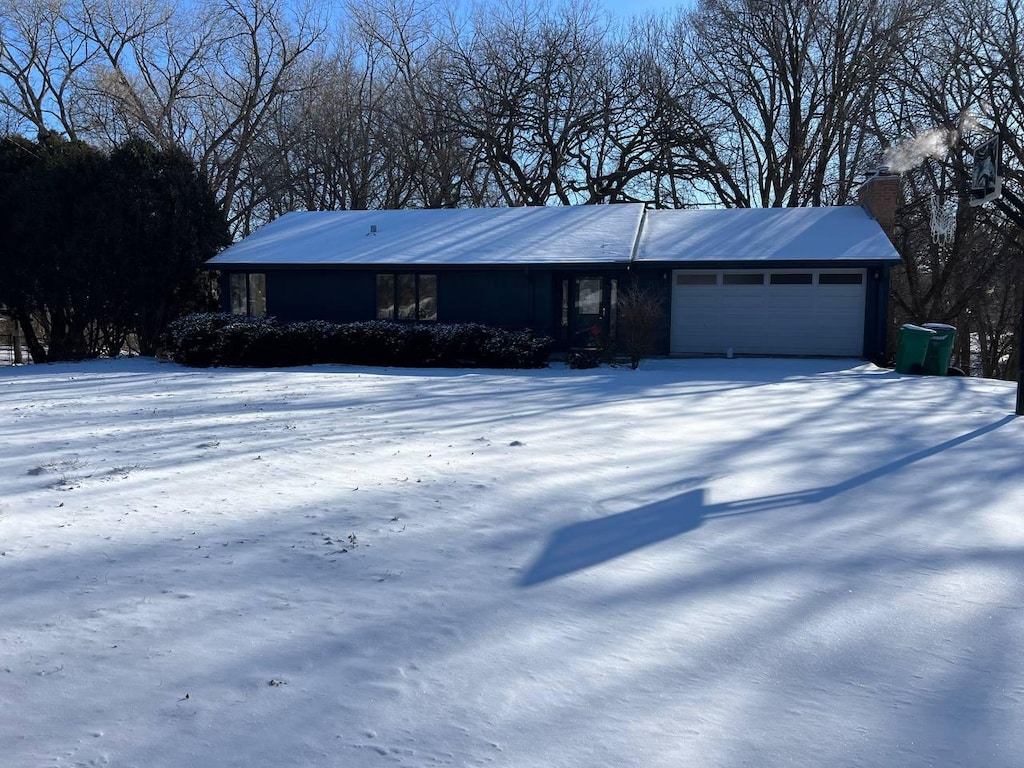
top-left (519, 416), bottom-right (1015, 587)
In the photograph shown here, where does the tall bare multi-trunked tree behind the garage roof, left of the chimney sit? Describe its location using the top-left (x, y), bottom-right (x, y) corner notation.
top-left (655, 0), bottom-right (930, 207)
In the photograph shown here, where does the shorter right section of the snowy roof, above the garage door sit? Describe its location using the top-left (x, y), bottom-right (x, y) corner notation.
top-left (636, 206), bottom-right (899, 263)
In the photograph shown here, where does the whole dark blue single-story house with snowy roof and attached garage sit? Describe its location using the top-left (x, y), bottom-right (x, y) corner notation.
top-left (207, 193), bottom-right (899, 359)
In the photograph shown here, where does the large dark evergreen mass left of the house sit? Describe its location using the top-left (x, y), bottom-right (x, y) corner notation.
top-left (0, 132), bottom-right (229, 361)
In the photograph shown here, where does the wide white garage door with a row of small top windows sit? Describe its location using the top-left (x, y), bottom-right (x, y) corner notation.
top-left (671, 269), bottom-right (866, 357)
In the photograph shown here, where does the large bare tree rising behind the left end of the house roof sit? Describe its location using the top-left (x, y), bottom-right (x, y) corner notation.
top-left (70, 0), bottom-right (324, 236)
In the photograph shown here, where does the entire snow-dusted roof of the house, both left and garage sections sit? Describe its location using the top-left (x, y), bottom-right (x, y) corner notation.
top-left (207, 204), bottom-right (899, 268)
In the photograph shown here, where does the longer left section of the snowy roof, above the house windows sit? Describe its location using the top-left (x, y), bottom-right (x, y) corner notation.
top-left (207, 204), bottom-right (644, 267)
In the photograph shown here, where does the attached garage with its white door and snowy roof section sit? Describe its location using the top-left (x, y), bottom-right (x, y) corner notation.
top-left (635, 206), bottom-right (899, 359)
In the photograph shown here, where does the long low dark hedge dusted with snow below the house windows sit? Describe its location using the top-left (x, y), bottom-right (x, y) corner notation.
top-left (164, 313), bottom-right (552, 368)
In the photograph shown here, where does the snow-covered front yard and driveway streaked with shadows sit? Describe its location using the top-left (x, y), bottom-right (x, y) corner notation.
top-left (0, 358), bottom-right (1024, 768)
